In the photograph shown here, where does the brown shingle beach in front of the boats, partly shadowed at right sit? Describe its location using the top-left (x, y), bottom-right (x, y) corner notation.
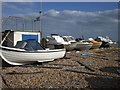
top-left (2, 49), bottom-right (120, 89)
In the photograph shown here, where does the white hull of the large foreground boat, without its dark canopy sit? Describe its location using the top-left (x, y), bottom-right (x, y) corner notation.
top-left (0, 47), bottom-right (66, 65)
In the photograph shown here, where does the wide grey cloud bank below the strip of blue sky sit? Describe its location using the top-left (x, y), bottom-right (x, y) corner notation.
top-left (2, 7), bottom-right (118, 40)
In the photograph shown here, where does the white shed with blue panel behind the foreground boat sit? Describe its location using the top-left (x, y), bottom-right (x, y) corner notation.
top-left (2, 30), bottom-right (41, 47)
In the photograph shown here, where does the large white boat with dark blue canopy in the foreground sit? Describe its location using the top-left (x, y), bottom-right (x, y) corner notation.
top-left (0, 39), bottom-right (66, 65)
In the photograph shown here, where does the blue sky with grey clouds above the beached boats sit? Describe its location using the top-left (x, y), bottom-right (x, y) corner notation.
top-left (2, 2), bottom-right (118, 40)
